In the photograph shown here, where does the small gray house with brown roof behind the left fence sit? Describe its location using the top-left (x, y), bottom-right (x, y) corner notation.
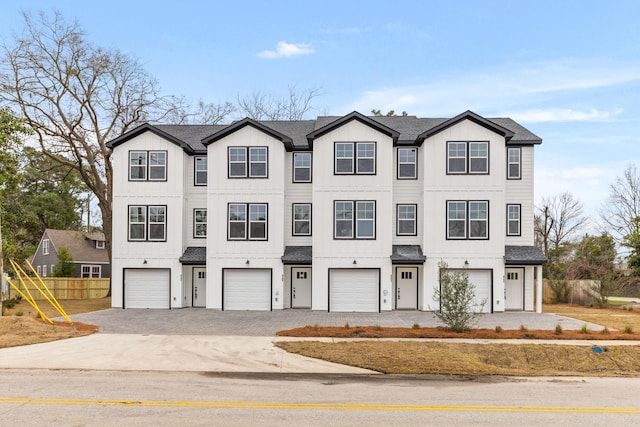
top-left (30, 228), bottom-right (111, 278)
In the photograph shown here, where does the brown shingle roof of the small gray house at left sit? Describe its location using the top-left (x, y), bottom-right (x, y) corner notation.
top-left (45, 228), bottom-right (109, 263)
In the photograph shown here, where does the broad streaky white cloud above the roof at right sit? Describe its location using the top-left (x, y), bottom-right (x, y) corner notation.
top-left (340, 61), bottom-right (640, 121)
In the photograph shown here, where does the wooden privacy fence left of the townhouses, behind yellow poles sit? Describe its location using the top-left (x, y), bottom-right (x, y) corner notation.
top-left (9, 277), bottom-right (111, 300)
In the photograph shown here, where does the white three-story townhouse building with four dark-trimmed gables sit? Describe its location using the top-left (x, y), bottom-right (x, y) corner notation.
top-left (107, 111), bottom-right (546, 312)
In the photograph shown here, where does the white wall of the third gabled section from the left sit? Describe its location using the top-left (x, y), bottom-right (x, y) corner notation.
top-left (312, 120), bottom-right (394, 310)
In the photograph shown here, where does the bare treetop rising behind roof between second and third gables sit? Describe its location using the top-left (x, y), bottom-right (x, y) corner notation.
top-left (237, 86), bottom-right (320, 120)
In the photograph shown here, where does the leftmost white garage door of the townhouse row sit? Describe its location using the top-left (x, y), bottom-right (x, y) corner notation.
top-left (124, 269), bottom-right (171, 308)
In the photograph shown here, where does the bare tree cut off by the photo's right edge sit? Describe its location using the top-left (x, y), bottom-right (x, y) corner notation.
top-left (600, 163), bottom-right (640, 243)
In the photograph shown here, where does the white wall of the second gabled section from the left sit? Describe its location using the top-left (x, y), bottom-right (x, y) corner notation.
top-left (207, 126), bottom-right (286, 310)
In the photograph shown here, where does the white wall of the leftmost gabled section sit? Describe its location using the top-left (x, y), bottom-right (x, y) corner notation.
top-left (111, 132), bottom-right (188, 308)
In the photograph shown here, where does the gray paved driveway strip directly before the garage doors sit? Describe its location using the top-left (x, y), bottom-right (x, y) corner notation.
top-left (67, 308), bottom-right (602, 337)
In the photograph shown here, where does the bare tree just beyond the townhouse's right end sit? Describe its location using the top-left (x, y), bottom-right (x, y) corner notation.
top-left (535, 191), bottom-right (587, 276)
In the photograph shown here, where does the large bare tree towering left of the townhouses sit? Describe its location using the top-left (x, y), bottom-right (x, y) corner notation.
top-left (0, 12), bottom-right (204, 280)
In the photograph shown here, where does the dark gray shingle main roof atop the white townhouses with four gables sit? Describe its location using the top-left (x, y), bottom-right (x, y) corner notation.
top-left (107, 111), bottom-right (542, 154)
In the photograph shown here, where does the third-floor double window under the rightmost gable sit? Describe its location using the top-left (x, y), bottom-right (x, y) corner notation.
top-left (447, 141), bottom-right (489, 174)
